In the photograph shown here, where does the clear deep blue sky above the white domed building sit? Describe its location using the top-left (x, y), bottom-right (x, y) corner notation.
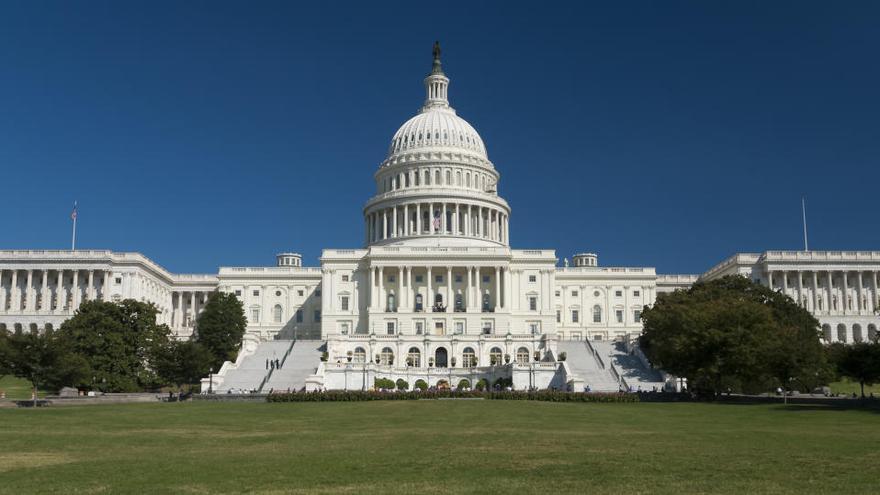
top-left (0, 1), bottom-right (880, 273)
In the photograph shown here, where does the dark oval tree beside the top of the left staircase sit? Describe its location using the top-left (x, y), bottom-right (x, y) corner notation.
top-left (196, 291), bottom-right (247, 369)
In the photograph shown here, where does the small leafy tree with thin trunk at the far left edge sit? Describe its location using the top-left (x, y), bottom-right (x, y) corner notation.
top-left (5, 330), bottom-right (90, 405)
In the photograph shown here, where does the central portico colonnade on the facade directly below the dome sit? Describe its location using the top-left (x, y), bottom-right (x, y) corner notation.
top-left (369, 266), bottom-right (511, 312)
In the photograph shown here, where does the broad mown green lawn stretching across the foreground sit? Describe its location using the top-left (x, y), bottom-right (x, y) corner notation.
top-left (0, 401), bottom-right (880, 495)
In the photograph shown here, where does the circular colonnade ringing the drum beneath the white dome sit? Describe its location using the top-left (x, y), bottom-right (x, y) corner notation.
top-left (365, 202), bottom-right (509, 244)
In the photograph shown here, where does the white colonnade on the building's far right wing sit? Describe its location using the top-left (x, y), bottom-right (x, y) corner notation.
top-left (767, 270), bottom-right (880, 315)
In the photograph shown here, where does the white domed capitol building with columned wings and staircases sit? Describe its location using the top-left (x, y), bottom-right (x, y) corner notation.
top-left (0, 45), bottom-right (880, 392)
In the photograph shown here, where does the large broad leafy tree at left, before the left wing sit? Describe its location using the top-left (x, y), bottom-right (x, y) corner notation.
top-left (58, 299), bottom-right (171, 392)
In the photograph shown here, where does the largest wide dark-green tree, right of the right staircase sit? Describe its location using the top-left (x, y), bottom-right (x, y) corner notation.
top-left (639, 276), bottom-right (827, 397)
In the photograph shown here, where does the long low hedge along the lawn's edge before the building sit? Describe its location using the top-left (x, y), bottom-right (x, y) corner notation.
top-left (266, 390), bottom-right (639, 403)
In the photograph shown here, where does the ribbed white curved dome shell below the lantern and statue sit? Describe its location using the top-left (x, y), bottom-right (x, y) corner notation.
top-left (388, 107), bottom-right (489, 160)
